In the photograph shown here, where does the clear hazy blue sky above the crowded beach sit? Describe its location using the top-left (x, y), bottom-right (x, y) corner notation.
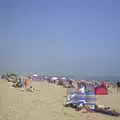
top-left (0, 0), bottom-right (120, 76)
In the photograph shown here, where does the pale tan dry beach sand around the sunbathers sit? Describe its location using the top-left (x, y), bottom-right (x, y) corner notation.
top-left (0, 80), bottom-right (120, 120)
